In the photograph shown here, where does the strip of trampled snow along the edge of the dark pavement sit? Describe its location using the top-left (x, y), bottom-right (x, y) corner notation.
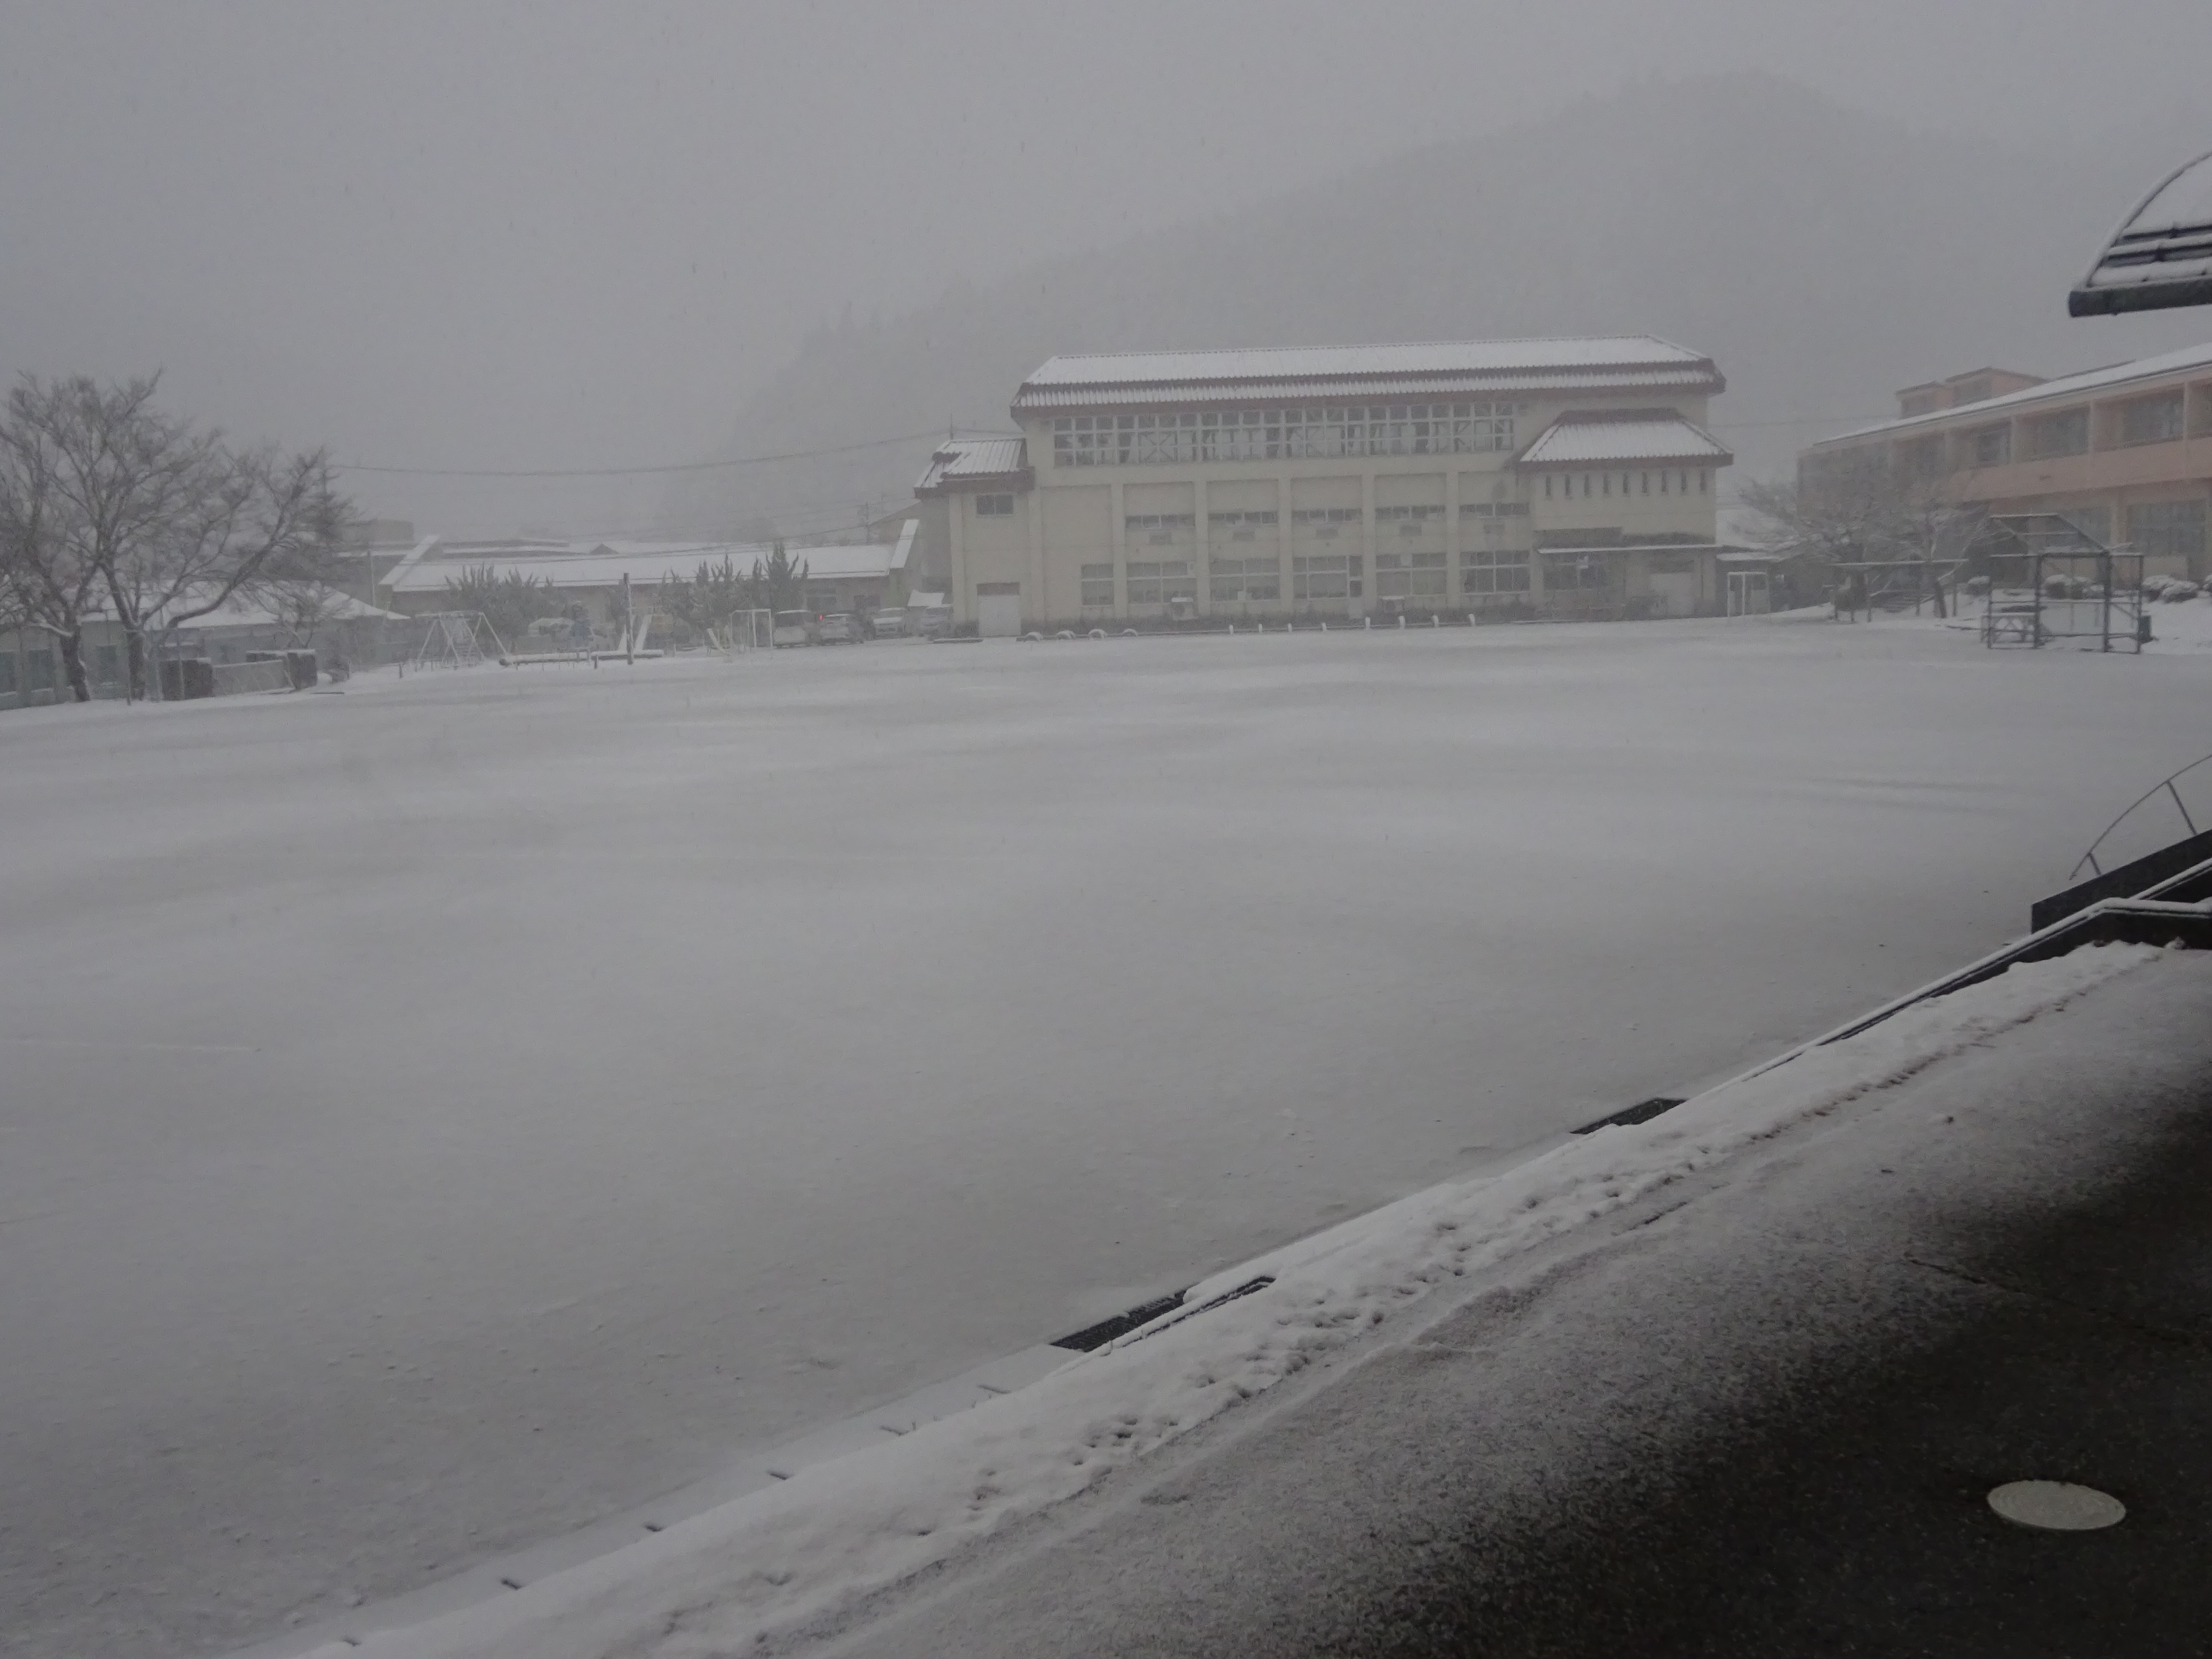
top-left (345, 945), bottom-right (2163, 1659)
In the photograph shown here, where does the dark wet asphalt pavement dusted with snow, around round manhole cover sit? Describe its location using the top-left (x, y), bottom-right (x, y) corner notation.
top-left (823, 951), bottom-right (2212, 1659)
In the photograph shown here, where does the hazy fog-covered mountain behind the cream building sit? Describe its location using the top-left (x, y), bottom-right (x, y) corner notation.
top-left (670, 75), bottom-right (2212, 533)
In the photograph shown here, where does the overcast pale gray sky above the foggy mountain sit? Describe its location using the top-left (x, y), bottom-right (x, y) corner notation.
top-left (0, 0), bottom-right (2212, 531)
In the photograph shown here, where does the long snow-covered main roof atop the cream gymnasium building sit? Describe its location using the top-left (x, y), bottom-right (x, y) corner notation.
top-left (1013, 334), bottom-right (1725, 412)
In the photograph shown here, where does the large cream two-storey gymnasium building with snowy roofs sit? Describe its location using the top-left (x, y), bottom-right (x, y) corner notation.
top-left (916, 336), bottom-right (1765, 635)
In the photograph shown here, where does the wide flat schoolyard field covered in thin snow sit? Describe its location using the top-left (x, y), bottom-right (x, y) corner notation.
top-left (0, 617), bottom-right (2212, 1657)
